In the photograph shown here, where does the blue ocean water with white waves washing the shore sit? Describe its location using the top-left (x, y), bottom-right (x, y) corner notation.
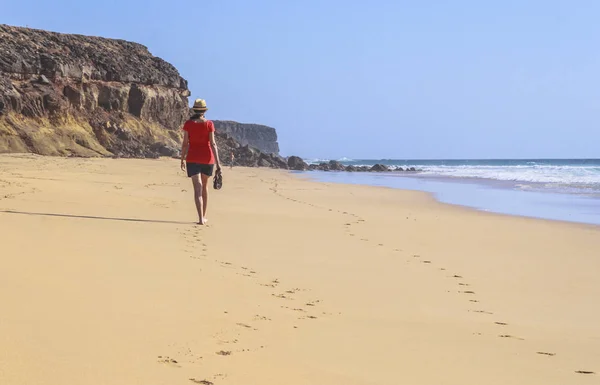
top-left (309, 159), bottom-right (600, 224)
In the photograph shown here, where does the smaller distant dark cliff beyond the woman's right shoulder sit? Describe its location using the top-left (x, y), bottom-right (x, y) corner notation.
top-left (214, 120), bottom-right (279, 154)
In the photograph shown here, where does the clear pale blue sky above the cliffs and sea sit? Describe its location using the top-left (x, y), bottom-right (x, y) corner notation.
top-left (0, 0), bottom-right (600, 159)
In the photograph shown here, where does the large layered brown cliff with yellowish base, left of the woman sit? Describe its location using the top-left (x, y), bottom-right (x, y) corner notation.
top-left (0, 25), bottom-right (190, 157)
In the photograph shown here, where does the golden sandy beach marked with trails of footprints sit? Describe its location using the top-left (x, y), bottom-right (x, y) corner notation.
top-left (0, 155), bottom-right (600, 385)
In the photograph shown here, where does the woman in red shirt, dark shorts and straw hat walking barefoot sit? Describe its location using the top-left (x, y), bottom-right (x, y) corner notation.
top-left (181, 99), bottom-right (221, 225)
